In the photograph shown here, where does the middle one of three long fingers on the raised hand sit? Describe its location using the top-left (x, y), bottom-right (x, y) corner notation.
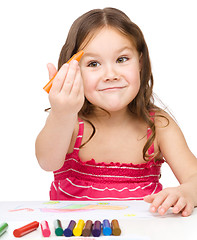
top-left (62, 60), bottom-right (78, 94)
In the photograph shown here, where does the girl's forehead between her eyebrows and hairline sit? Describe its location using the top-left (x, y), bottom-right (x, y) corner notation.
top-left (79, 26), bottom-right (136, 50)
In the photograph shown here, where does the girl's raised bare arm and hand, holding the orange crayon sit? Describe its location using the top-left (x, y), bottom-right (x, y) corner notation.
top-left (36, 61), bottom-right (84, 171)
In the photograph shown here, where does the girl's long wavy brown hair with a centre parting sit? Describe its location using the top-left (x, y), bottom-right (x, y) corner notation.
top-left (58, 8), bottom-right (168, 160)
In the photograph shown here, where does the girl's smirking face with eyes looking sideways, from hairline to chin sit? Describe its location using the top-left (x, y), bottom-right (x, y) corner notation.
top-left (80, 27), bottom-right (140, 112)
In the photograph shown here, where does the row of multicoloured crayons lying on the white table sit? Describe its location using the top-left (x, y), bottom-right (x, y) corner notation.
top-left (0, 219), bottom-right (121, 237)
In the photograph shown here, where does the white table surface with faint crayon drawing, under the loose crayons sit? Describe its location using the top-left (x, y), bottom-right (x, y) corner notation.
top-left (0, 201), bottom-right (197, 240)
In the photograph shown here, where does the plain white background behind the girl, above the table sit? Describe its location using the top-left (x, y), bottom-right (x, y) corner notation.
top-left (0, 0), bottom-right (197, 200)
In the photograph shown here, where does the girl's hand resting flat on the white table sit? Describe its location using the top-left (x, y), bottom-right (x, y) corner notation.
top-left (144, 185), bottom-right (194, 217)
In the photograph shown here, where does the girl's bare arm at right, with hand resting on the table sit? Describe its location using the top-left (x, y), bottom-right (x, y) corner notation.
top-left (144, 111), bottom-right (197, 216)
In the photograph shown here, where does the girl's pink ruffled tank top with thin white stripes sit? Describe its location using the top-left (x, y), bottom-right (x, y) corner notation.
top-left (50, 119), bottom-right (164, 201)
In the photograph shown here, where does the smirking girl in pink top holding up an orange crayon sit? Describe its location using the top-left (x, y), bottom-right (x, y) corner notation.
top-left (36, 8), bottom-right (197, 216)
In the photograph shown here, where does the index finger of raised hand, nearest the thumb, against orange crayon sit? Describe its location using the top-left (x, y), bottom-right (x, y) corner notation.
top-left (49, 63), bottom-right (69, 94)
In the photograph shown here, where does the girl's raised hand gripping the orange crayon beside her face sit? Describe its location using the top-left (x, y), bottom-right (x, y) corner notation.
top-left (47, 60), bottom-right (84, 116)
